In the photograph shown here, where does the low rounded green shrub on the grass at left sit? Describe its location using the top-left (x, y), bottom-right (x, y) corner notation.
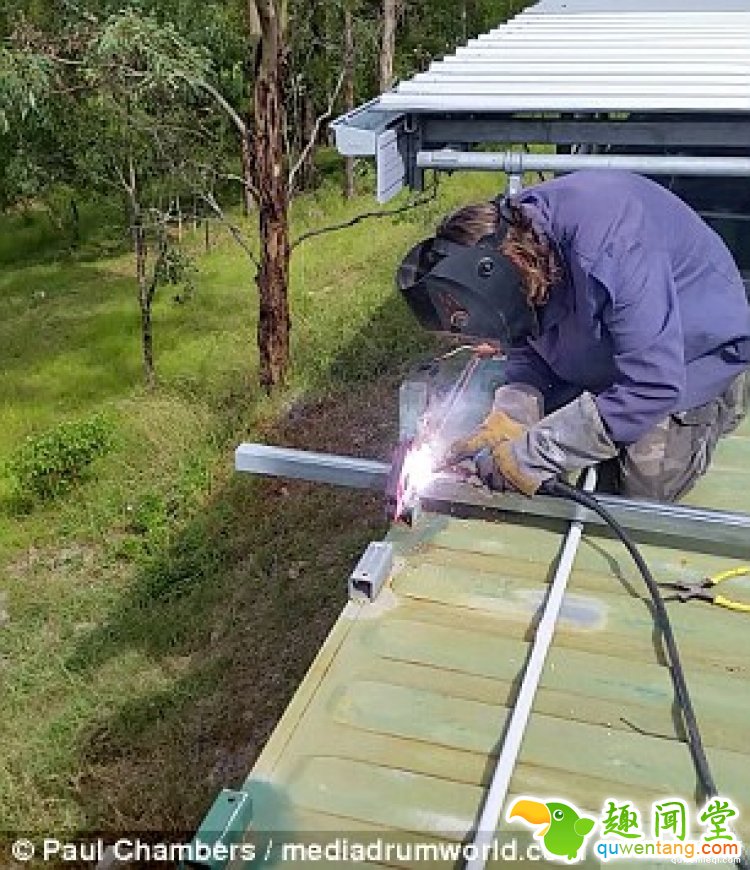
top-left (9, 414), bottom-right (114, 499)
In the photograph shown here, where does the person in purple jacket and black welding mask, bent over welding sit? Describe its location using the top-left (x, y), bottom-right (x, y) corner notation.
top-left (397, 170), bottom-right (750, 501)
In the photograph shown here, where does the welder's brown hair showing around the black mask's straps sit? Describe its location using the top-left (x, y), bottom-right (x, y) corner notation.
top-left (437, 202), bottom-right (560, 305)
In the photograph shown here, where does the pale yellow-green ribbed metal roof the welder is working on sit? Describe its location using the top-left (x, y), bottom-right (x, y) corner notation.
top-left (239, 422), bottom-right (750, 867)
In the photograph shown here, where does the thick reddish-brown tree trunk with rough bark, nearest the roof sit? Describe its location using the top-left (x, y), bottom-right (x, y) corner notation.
top-left (253, 0), bottom-right (290, 392)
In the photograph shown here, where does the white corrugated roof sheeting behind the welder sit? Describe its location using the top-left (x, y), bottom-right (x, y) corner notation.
top-left (379, 0), bottom-right (750, 112)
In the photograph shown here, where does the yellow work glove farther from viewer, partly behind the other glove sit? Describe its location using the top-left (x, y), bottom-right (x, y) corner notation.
top-left (446, 384), bottom-right (543, 465)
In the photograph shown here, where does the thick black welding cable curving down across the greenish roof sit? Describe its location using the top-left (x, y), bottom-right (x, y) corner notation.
top-left (539, 478), bottom-right (750, 870)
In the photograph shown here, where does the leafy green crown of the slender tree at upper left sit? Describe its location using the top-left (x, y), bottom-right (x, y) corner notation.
top-left (0, 8), bottom-right (226, 206)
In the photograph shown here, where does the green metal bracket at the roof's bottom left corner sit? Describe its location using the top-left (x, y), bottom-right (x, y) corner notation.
top-left (181, 788), bottom-right (253, 870)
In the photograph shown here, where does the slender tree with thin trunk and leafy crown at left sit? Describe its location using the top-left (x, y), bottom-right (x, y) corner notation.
top-left (0, 11), bottom-right (223, 385)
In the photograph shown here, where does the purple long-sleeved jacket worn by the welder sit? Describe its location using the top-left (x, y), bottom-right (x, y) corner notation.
top-left (507, 170), bottom-right (750, 445)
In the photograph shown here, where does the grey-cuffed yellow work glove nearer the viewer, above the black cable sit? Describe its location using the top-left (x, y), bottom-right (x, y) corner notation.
top-left (477, 393), bottom-right (619, 495)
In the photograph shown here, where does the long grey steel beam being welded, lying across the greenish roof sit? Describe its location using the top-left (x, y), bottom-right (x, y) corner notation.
top-left (235, 444), bottom-right (750, 556)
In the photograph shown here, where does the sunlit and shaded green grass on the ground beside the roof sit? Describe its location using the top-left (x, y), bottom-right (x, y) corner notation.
top-left (0, 165), bottom-right (502, 835)
